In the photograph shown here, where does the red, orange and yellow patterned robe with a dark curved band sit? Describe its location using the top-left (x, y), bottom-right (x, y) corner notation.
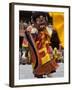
top-left (26, 26), bottom-right (58, 76)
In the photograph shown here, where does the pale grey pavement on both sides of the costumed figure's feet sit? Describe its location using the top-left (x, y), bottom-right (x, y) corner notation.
top-left (19, 63), bottom-right (64, 79)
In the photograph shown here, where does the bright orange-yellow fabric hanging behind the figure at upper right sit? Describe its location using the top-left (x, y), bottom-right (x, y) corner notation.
top-left (49, 12), bottom-right (64, 47)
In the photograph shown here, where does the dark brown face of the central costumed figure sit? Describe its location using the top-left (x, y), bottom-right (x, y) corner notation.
top-left (35, 15), bottom-right (46, 30)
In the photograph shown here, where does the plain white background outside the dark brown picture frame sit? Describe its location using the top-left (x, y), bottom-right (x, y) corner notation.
top-left (0, 0), bottom-right (72, 90)
